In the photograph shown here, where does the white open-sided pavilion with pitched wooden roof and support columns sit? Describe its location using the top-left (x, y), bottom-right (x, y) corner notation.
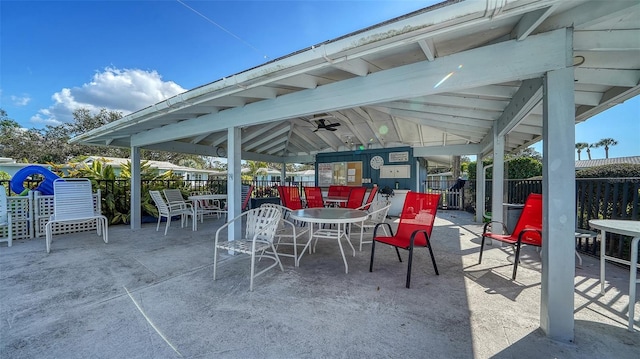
top-left (72, 0), bottom-right (640, 342)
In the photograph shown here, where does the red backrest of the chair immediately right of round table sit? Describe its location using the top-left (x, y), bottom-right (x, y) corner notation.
top-left (396, 192), bottom-right (440, 246)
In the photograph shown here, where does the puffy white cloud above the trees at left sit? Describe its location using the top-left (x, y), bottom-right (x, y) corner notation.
top-left (31, 67), bottom-right (186, 125)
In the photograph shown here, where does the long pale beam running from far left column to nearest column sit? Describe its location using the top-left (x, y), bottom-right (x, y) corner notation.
top-left (131, 29), bottom-right (567, 146)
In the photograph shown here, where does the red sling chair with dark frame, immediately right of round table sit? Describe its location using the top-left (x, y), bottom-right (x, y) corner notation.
top-left (369, 192), bottom-right (440, 288)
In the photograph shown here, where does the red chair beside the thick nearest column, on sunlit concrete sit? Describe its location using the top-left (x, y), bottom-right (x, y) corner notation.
top-left (478, 193), bottom-right (542, 280)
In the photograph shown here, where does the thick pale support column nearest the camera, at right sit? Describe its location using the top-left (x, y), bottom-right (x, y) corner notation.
top-left (540, 65), bottom-right (576, 342)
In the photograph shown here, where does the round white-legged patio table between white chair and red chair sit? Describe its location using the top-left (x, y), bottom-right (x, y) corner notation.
top-left (289, 208), bottom-right (369, 273)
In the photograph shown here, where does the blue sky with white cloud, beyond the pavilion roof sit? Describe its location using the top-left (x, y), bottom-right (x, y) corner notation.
top-left (0, 0), bottom-right (640, 159)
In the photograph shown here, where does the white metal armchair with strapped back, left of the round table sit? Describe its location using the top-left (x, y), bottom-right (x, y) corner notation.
top-left (213, 207), bottom-right (284, 291)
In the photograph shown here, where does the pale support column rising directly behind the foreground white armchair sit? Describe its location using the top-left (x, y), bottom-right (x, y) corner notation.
top-left (227, 127), bottom-right (242, 240)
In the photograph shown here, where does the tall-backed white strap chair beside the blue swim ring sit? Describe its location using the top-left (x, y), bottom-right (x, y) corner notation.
top-left (46, 178), bottom-right (109, 253)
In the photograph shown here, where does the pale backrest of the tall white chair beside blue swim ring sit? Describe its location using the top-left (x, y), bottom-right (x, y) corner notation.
top-left (53, 178), bottom-right (96, 221)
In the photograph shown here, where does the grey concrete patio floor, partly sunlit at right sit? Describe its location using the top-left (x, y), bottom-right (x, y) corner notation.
top-left (0, 211), bottom-right (640, 359)
